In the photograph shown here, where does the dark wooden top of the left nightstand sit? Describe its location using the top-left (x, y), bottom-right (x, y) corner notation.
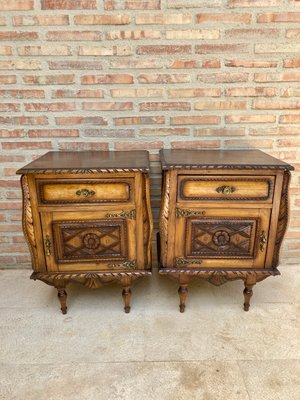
top-left (17, 150), bottom-right (149, 174)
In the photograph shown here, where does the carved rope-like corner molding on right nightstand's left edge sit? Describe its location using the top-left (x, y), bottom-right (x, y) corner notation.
top-left (159, 171), bottom-right (170, 264)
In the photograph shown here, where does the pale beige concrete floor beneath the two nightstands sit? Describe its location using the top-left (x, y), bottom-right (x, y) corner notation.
top-left (0, 266), bottom-right (300, 400)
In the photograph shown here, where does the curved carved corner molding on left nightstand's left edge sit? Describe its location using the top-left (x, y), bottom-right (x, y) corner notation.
top-left (21, 175), bottom-right (37, 270)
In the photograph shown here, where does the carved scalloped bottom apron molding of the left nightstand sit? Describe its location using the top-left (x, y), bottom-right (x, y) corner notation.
top-left (30, 270), bottom-right (151, 289)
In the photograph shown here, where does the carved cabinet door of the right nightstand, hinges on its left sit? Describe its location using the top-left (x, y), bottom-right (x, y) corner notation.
top-left (174, 208), bottom-right (270, 268)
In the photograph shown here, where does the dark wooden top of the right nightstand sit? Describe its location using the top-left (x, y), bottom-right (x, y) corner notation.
top-left (160, 149), bottom-right (294, 170)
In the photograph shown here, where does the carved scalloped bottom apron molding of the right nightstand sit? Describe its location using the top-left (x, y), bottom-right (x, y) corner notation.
top-left (159, 268), bottom-right (280, 286)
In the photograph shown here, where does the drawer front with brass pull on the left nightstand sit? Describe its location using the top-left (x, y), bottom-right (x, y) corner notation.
top-left (37, 178), bottom-right (134, 204)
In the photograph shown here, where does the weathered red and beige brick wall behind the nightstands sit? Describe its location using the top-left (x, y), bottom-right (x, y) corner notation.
top-left (0, 0), bottom-right (300, 267)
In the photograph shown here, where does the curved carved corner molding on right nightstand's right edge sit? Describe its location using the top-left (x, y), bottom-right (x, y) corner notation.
top-left (272, 171), bottom-right (291, 268)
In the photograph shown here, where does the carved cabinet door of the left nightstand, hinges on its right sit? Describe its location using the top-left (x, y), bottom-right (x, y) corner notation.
top-left (41, 210), bottom-right (136, 271)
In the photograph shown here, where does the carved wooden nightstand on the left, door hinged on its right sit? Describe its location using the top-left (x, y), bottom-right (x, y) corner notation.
top-left (17, 151), bottom-right (152, 314)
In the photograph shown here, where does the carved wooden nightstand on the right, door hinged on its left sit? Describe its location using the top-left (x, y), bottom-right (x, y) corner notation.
top-left (159, 150), bottom-right (294, 312)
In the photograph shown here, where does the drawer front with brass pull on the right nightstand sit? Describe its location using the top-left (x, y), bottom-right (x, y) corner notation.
top-left (177, 175), bottom-right (275, 203)
